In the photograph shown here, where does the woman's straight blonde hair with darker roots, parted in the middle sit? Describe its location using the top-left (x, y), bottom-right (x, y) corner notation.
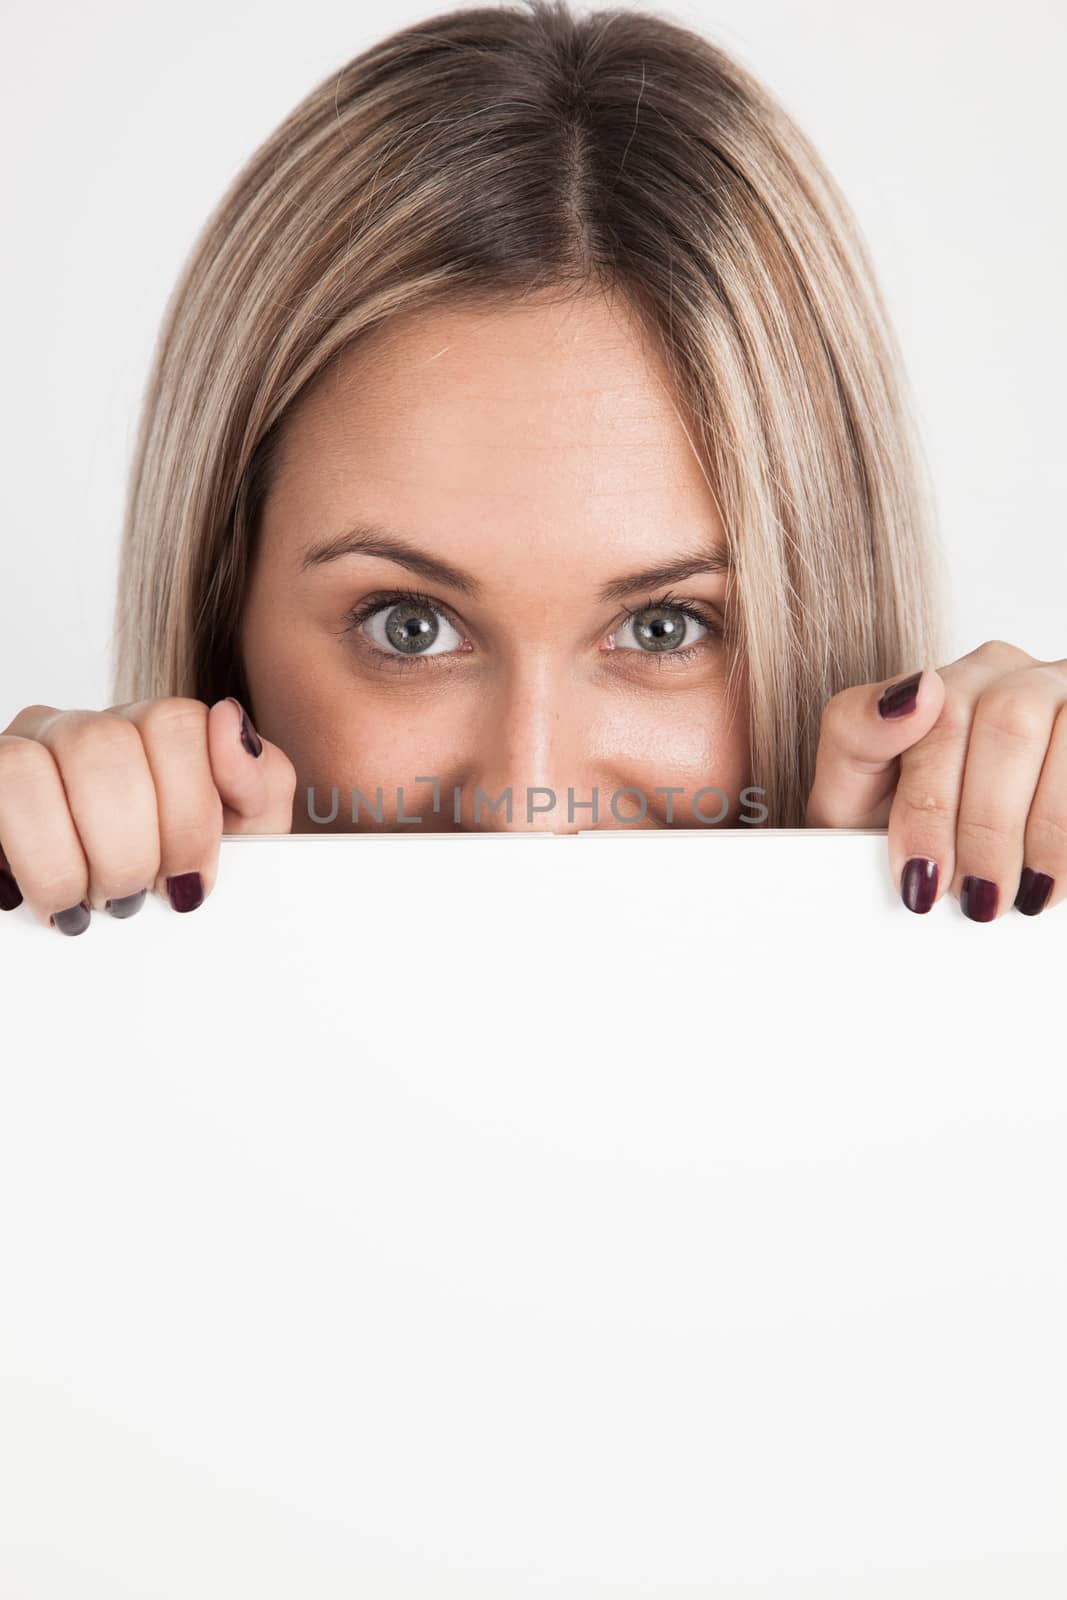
top-left (114, 0), bottom-right (944, 827)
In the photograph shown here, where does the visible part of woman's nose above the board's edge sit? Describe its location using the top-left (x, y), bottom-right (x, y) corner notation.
top-left (464, 654), bottom-right (592, 832)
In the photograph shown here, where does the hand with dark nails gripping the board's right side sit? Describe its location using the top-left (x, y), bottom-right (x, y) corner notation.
top-left (806, 638), bottom-right (1067, 922)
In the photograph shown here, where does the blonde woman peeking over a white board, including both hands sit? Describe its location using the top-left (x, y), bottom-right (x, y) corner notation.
top-left (0, 0), bottom-right (1067, 933)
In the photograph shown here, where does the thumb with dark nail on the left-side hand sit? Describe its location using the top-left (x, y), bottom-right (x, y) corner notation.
top-left (208, 694), bottom-right (296, 834)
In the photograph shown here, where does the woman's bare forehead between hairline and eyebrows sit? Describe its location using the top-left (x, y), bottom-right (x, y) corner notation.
top-left (270, 296), bottom-right (718, 582)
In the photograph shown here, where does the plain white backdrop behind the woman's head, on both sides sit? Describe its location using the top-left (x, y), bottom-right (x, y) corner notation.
top-left (0, 0), bottom-right (1067, 726)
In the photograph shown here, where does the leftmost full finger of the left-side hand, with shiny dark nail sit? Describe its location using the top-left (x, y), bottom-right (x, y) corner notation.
top-left (0, 733), bottom-right (90, 933)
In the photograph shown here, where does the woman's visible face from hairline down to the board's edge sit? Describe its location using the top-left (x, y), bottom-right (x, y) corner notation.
top-left (240, 298), bottom-right (749, 832)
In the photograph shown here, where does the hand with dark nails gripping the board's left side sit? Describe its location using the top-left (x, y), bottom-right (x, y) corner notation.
top-left (0, 698), bottom-right (296, 933)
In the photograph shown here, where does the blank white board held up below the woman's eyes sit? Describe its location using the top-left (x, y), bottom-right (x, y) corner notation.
top-left (0, 829), bottom-right (1067, 1600)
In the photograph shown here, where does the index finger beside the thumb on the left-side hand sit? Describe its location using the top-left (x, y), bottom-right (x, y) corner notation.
top-left (115, 696), bottom-right (222, 912)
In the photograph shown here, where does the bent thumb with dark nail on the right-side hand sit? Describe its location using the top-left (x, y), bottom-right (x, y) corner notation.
top-left (805, 667), bottom-right (945, 827)
